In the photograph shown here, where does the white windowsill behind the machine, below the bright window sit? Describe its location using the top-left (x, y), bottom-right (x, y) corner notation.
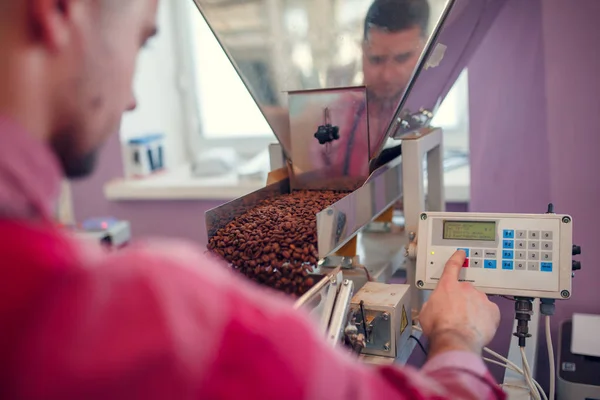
top-left (104, 166), bottom-right (471, 203)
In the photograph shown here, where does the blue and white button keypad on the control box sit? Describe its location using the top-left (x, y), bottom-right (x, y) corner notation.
top-left (450, 229), bottom-right (553, 272)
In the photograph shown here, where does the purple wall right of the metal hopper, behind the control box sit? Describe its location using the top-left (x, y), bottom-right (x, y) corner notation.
top-left (469, 0), bottom-right (600, 386)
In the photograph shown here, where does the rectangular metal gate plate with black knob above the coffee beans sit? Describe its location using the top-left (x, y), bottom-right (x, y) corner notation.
top-left (289, 87), bottom-right (369, 191)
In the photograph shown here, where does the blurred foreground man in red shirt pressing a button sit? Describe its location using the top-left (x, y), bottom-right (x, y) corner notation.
top-left (0, 0), bottom-right (504, 400)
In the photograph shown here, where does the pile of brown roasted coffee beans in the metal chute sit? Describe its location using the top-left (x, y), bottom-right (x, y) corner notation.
top-left (208, 191), bottom-right (347, 296)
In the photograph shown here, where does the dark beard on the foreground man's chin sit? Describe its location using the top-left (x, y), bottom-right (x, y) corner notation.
top-left (50, 135), bottom-right (98, 179)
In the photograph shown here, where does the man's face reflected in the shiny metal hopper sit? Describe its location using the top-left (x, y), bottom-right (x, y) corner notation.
top-left (363, 26), bottom-right (425, 101)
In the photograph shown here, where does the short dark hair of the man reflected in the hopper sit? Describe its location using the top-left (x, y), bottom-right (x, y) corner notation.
top-left (364, 0), bottom-right (429, 40)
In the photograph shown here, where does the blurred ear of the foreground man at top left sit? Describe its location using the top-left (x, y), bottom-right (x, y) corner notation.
top-left (28, 0), bottom-right (81, 51)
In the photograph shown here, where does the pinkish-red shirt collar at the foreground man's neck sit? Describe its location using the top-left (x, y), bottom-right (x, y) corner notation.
top-left (0, 116), bottom-right (62, 219)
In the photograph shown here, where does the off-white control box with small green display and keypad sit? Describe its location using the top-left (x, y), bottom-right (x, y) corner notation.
top-left (416, 212), bottom-right (573, 299)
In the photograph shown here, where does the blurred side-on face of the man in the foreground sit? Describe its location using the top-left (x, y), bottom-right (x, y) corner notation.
top-left (50, 0), bottom-right (158, 178)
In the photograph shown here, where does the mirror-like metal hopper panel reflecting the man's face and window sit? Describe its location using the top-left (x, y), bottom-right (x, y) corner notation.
top-left (194, 0), bottom-right (458, 161)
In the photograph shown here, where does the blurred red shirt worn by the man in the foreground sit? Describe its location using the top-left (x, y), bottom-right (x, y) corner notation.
top-left (0, 115), bottom-right (505, 400)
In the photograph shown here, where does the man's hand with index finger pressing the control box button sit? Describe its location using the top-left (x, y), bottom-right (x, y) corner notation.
top-left (419, 250), bottom-right (500, 357)
